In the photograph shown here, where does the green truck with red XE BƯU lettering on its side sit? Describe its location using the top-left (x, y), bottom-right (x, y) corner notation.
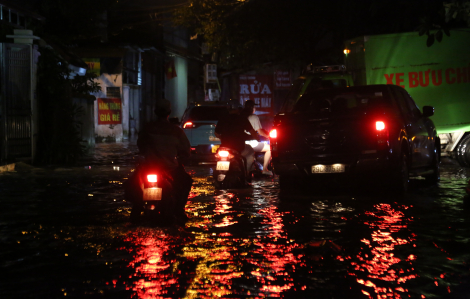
top-left (344, 28), bottom-right (470, 166)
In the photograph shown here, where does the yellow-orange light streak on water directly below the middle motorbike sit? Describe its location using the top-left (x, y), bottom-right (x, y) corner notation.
top-left (183, 190), bottom-right (246, 298)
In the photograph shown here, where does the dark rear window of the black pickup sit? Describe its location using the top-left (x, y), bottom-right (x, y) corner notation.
top-left (293, 88), bottom-right (394, 115)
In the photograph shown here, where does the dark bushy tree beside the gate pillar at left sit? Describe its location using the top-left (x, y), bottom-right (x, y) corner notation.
top-left (36, 47), bottom-right (100, 164)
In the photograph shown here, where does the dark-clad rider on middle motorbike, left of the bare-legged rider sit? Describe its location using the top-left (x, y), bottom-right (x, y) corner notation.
top-left (215, 109), bottom-right (259, 177)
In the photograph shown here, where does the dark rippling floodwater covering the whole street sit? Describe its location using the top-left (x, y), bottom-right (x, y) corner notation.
top-left (0, 143), bottom-right (470, 299)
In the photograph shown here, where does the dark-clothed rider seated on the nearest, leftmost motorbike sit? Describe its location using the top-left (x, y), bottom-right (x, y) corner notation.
top-left (131, 99), bottom-right (193, 220)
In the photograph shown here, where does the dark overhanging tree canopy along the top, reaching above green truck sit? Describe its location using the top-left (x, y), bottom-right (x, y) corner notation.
top-left (174, 0), bottom-right (469, 68)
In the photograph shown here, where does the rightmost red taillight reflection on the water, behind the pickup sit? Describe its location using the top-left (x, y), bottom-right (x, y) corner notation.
top-left (350, 204), bottom-right (417, 298)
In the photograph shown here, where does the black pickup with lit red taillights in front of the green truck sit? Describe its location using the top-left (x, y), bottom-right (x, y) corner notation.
top-left (270, 85), bottom-right (440, 194)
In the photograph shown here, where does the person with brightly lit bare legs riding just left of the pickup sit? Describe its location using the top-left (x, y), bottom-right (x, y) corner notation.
top-left (241, 100), bottom-right (273, 176)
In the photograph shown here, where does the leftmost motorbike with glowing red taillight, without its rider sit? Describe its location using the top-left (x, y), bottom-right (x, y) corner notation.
top-left (125, 160), bottom-right (176, 224)
